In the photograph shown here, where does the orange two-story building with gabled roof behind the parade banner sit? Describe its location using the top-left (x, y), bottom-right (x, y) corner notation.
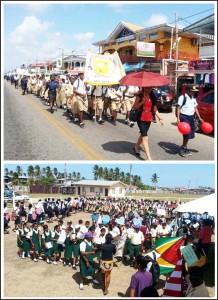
top-left (93, 22), bottom-right (200, 86)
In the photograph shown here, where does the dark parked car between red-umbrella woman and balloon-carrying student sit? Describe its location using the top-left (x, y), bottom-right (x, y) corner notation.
top-left (155, 85), bottom-right (173, 112)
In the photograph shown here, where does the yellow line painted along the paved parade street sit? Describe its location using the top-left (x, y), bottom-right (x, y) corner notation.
top-left (25, 97), bottom-right (105, 160)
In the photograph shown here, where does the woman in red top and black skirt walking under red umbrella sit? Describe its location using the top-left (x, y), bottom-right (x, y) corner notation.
top-left (133, 87), bottom-right (164, 160)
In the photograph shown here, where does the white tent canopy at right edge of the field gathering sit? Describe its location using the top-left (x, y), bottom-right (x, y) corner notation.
top-left (173, 194), bottom-right (217, 217)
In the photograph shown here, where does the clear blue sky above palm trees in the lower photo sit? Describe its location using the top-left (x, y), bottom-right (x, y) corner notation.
top-left (4, 162), bottom-right (215, 188)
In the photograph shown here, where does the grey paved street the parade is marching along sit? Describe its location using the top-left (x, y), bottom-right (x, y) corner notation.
top-left (4, 81), bottom-right (214, 161)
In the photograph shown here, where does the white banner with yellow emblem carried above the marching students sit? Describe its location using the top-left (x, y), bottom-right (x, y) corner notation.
top-left (85, 50), bottom-right (126, 85)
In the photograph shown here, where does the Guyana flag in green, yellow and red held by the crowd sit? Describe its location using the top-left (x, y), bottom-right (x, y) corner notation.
top-left (155, 237), bottom-right (184, 274)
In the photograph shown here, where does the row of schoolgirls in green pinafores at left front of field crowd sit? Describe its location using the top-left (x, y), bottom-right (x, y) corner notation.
top-left (16, 220), bottom-right (90, 270)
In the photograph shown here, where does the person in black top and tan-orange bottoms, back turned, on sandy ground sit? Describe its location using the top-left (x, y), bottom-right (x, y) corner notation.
top-left (100, 233), bottom-right (116, 295)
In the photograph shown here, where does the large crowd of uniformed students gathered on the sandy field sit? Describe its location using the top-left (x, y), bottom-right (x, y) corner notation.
top-left (4, 197), bottom-right (214, 297)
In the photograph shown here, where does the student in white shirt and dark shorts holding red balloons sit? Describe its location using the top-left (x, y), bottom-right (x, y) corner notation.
top-left (176, 84), bottom-right (204, 157)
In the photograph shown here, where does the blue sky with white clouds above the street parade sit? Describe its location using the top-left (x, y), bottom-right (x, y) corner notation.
top-left (1, 1), bottom-right (216, 72)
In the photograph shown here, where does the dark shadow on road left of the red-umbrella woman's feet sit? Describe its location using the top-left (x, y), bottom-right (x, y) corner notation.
top-left (102, 141), bottom-right (144, 160)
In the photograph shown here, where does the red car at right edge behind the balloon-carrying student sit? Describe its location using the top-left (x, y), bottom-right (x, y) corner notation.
top-left (195, 90), bottom-right (214, 132)
